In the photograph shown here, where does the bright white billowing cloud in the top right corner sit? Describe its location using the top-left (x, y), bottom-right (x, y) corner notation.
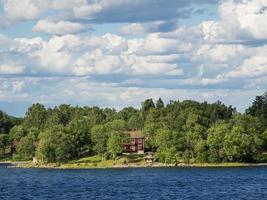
top-left (200, 0), bottom-right (267, 42)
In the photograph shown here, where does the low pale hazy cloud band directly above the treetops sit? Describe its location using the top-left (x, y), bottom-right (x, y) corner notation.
top-left (0, 78), bottom-right (263, 110)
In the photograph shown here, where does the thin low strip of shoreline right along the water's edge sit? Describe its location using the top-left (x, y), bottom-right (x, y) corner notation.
top-left (6, 161), bottom-right (267, 169)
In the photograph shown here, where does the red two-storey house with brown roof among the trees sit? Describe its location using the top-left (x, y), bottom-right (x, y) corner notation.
top-left (123, 131), bottom-right (145, 154)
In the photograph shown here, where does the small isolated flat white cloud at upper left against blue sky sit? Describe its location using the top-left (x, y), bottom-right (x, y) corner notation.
top-left (32, 19), bottom-right (90, 35)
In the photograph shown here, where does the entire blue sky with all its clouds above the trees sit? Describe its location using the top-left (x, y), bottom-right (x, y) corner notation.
top-left (0, 0), bottom-right (267, 116)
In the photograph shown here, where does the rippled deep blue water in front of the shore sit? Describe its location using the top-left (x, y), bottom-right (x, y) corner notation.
top-left (0, 165), bottom-right (267, 200)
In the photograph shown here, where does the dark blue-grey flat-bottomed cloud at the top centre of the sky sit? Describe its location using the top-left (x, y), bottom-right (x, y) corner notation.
top-left (73, 0), bottom-right (218, 23)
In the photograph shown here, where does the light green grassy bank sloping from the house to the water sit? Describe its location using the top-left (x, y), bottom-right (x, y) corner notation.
top-left (14, 155), bottom-right (267, 169)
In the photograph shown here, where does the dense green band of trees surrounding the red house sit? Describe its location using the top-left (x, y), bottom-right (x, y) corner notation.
top-left (0, 93), bottom-right (267, 163)
